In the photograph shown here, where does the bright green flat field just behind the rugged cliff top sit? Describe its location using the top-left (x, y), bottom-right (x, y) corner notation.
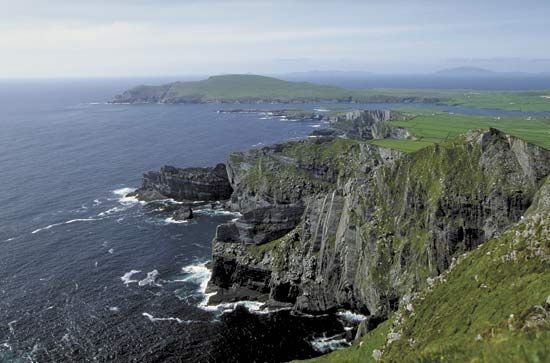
top-left (371, 110), bottom-right (550, 152)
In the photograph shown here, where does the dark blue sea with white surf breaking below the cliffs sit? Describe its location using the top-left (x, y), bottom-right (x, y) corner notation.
top-left (0, 79), bottom-right (548, 362)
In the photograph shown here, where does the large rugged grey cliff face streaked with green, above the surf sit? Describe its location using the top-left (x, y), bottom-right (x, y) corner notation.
top-left (211, 123), bottom-right (550, 318)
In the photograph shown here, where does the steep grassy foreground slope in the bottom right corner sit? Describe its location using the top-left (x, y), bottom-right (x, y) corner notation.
top-left (304, 179), bottom-right (550, 362)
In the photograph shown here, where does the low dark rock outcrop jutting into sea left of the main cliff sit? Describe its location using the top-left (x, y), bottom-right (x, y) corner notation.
top-left (136, 164), bottom-right (233, 201)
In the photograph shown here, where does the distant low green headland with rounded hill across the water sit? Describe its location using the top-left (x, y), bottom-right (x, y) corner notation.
top-left (113, 74), bottom-right (550, 111)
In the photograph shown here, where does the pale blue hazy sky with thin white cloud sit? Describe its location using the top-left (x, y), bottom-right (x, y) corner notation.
top-left (0, 0), bottom-right (550, 78)
